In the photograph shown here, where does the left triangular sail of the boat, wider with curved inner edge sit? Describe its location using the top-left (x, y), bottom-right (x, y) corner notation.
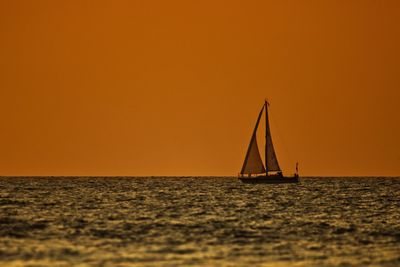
top-left (240, 106), bottom-right (265, 174)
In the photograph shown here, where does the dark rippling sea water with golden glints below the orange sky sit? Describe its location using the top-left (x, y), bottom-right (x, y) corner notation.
top-left (0, 177), bottom-right (400, 266)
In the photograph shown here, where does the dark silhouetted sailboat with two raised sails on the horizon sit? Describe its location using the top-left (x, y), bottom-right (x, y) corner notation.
top-left (239, 100), bottom-right (299, 184)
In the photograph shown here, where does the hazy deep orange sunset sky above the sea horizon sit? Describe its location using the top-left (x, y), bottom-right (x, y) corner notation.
top-left (0, 0), bottom-right (400, 175)
